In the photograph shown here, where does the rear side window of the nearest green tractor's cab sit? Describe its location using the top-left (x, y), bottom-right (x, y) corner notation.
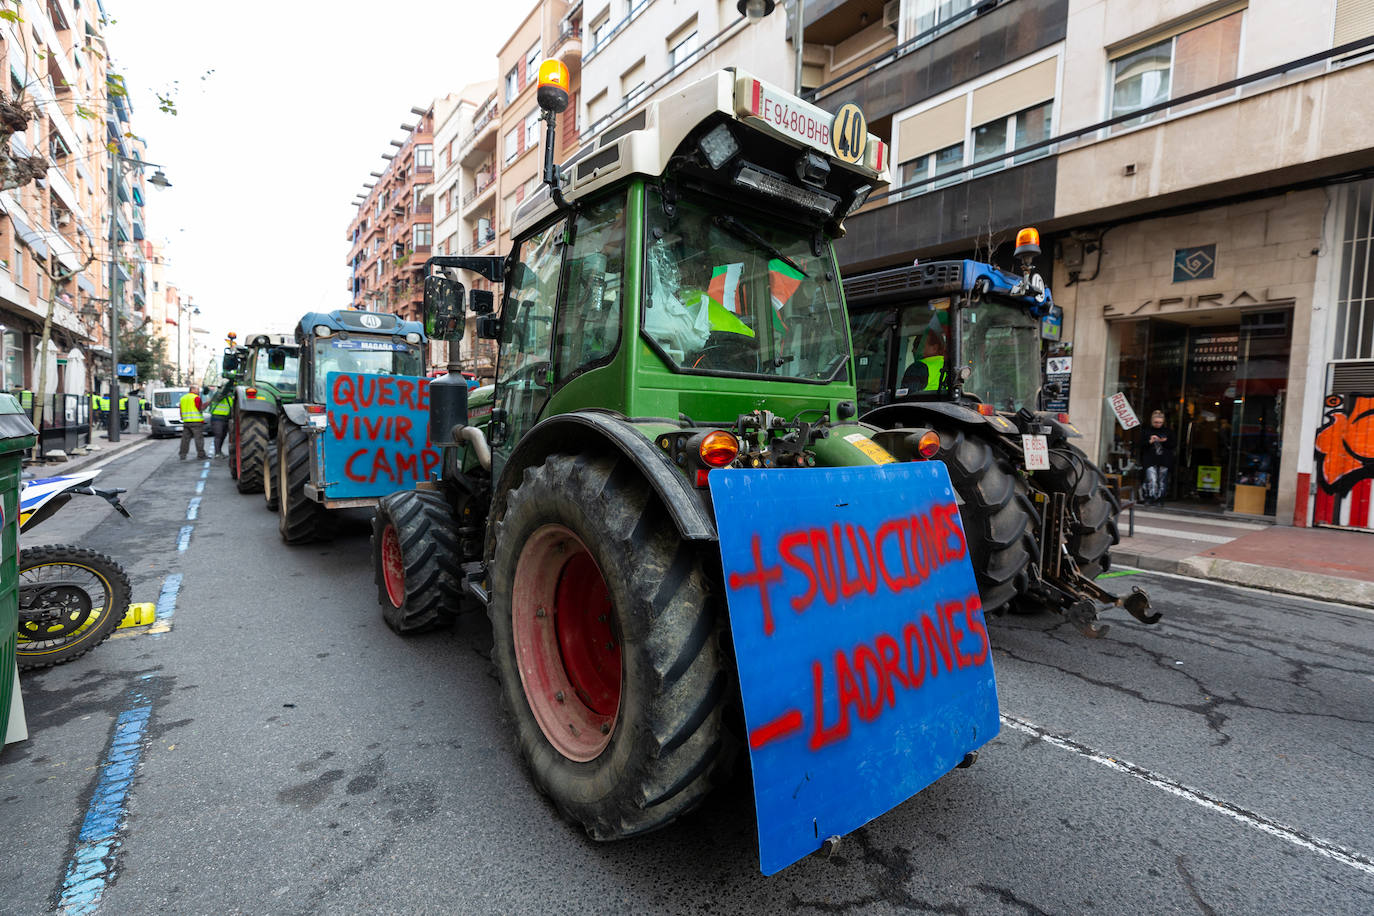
top-left (554, 194), bottom-right (625, 380)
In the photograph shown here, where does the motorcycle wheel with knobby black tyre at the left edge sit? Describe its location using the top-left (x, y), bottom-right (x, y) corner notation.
top-left (15, 544), bottom-right (132, 670)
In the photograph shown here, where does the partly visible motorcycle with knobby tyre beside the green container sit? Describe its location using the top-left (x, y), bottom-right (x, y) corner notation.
top-left (16, 471), bottom-right (132, 670)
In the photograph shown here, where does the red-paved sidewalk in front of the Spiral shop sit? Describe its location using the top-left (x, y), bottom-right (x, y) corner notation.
top-left (1112, 509), bottom-right (1374, 608)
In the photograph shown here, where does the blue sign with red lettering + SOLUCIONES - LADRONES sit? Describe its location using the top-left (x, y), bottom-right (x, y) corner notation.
top-left (709, 461), bottom-right (999, 875)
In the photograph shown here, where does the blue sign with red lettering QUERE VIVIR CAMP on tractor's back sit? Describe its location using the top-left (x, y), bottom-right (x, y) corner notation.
top-left (317, 372), bottom-right (440, 500)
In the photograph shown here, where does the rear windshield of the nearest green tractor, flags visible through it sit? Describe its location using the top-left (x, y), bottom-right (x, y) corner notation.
top-left (643, 191), bottom-right (849, 382)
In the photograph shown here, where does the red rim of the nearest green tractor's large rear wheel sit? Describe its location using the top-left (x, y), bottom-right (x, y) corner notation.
top-left (511, 525), bottom-right (621, 761)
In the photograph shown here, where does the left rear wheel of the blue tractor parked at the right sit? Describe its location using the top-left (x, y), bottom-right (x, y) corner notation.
top-left (936, 430), bottom-right (1037, 614)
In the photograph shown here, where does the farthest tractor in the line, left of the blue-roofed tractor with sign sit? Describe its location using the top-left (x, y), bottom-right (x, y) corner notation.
top-left (225, 334), bottom-right (298, 493)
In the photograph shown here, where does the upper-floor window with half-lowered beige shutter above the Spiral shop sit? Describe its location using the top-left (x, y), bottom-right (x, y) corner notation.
top-left (1110, 10), bottom-right (1245, 126)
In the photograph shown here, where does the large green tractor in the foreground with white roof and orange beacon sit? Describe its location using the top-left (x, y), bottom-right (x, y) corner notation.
top-left (372, 70), bottom-right (994, 862)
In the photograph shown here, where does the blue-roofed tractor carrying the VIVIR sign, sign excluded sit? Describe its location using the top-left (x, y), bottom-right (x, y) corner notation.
top-left (270, 309), bottom-right (429, 544)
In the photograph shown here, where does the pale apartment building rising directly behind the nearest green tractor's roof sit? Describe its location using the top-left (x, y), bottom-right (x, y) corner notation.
top-left (578, 0), bottom-right (796, 143)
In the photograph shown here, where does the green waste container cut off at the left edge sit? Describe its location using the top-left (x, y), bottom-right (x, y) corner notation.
top-left (0, 394), bottom-right (38, 747)
